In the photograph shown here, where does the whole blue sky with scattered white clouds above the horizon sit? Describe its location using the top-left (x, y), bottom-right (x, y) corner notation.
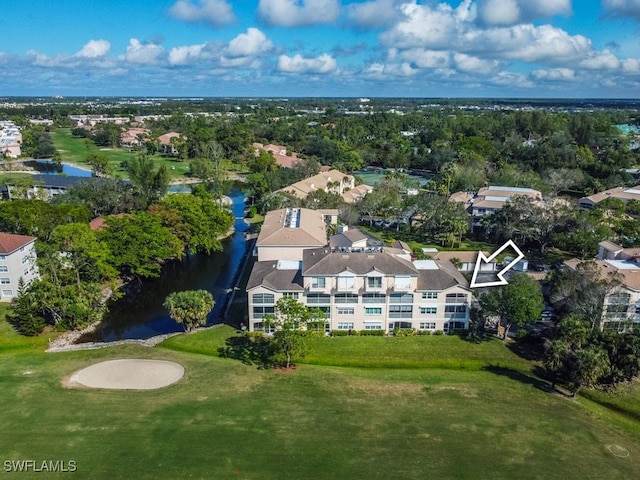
top-left (0, 0), bottom-right (640, 98)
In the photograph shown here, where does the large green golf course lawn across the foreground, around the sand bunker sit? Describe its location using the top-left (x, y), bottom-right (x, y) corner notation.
top-left (0, 321), bottom-right (640, 480)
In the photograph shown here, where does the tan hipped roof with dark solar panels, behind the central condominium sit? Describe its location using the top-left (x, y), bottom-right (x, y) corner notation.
top-left (256, 208), bottom-right (327, 247)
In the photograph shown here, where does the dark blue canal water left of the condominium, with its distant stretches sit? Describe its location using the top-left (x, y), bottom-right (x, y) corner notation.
top-left (28, 160), bottom-right (249, 342)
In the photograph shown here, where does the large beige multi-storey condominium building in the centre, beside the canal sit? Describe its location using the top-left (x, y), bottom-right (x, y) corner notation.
top-left (247, 209), bottom-right (471, 332)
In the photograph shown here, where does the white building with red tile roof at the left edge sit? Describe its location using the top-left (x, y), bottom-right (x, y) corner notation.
top-left (0, 232), bottom-right (40, 302)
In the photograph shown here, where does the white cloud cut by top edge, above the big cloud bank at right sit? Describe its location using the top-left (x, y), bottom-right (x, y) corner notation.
top-left (479, 0), bottom-right (572, 25)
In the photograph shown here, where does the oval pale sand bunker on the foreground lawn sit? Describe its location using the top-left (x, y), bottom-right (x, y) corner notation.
top-left (68, 359), bottom-right (184, 390)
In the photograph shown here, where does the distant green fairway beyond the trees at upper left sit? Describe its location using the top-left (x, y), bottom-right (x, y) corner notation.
top-left (51, 128), bottom-right (189, 180)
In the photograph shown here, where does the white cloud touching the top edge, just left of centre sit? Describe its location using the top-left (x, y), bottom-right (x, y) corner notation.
top-left (258, 0), bottom-right (340, 27)
